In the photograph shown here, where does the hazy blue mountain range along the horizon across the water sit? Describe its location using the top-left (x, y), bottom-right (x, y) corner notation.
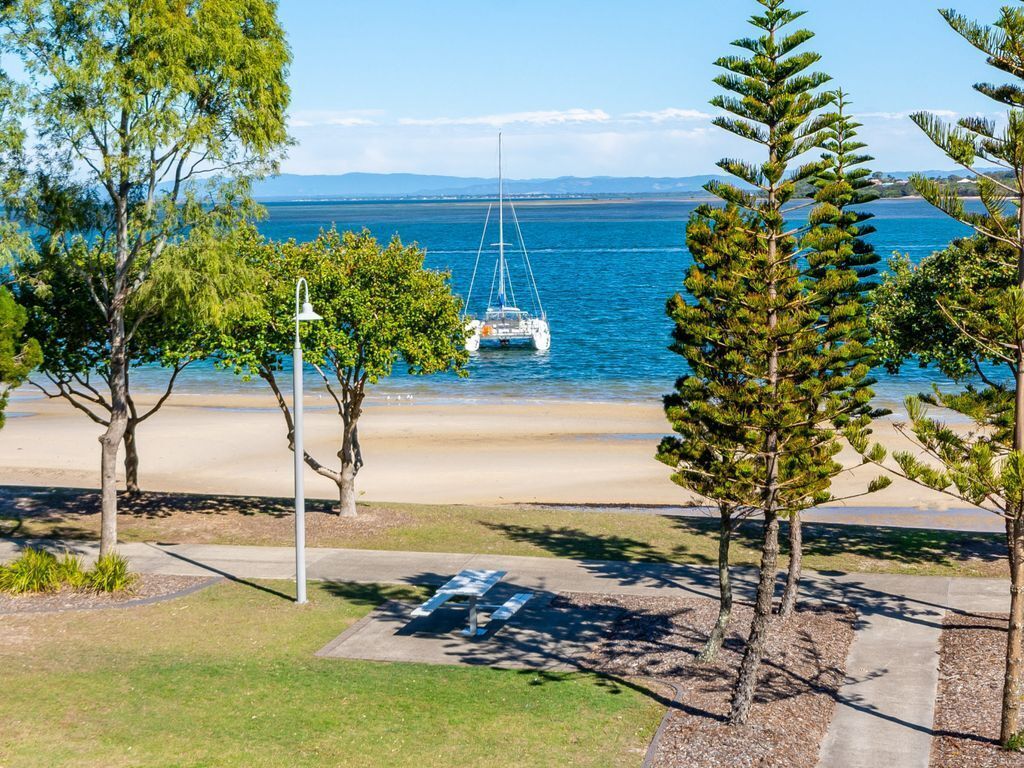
top-left (247, 171), bottom-right (983, 200)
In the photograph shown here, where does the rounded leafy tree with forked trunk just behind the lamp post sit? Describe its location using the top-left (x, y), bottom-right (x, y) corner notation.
top-left (218, 229), bottom-right (468, 516)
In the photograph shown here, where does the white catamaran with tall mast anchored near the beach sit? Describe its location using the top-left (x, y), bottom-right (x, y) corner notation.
top-left (466, 133), bottom-right (551, 352)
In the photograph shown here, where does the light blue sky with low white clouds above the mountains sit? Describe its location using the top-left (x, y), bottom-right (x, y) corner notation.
top-left (280, 0), bottom-right (1016, 178)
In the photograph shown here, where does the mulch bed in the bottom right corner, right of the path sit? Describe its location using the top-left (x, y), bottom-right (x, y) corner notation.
top-left (931, 613), bottom-right (1024, 768)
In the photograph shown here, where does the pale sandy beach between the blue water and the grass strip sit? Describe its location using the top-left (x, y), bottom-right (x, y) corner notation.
top-left (0, 390), bottom-right (991, 517)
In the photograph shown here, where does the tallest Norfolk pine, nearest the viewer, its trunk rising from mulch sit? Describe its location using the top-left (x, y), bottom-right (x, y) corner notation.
top-left (670, 0), bottom-right (885, 724)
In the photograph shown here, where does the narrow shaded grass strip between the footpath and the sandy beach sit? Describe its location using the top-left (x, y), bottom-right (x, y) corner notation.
top-left (0, 488), bottom-right (1007, 577)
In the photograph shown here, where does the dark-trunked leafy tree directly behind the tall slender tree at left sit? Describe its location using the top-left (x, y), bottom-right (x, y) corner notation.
top-left (18, 229), bottom-right (252, 495)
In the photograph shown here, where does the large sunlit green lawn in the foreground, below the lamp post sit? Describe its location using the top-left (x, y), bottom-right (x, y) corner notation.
top-left (0, 583), bottom-right (664, 768)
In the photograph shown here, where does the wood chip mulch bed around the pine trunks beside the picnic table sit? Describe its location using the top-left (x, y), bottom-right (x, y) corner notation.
top-left (564, 595), bottom-right (855, 768)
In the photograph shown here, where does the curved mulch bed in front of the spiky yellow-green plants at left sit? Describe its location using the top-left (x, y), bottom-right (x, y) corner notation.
top-left (0, 573), bottom-right (211, 613)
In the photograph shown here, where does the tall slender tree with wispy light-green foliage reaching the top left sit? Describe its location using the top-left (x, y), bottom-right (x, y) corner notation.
top-left (2, 0), bottom-right (290, 554)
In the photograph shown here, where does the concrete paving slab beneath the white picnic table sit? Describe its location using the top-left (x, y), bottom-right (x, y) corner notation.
top-left (316, 585), bottom-right (621, 671)
